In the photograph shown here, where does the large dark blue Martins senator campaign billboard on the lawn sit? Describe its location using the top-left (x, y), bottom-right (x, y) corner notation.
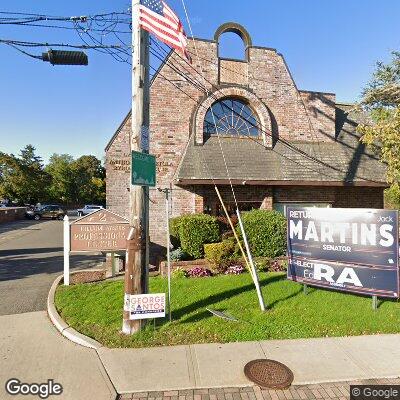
top-left (287, 207), bottom-right (399, 298)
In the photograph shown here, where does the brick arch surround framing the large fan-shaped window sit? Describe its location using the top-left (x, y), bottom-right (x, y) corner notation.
top-left (192, 86), bottom-right (272, 147)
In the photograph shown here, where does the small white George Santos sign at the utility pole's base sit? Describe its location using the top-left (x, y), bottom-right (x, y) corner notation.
top-left (124, 293), bottom-right (165, 319)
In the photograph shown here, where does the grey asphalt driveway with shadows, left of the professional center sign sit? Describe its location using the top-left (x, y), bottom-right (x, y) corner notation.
top-left (0, 220), bottom-right (102, 315)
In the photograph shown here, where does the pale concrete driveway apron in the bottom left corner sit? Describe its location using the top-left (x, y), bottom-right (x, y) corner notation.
top-left (0, 311), bottom-right (117, 400)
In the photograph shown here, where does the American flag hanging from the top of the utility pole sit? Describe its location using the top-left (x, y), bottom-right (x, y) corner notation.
top-left (139, 0), bottom-right (191, 62)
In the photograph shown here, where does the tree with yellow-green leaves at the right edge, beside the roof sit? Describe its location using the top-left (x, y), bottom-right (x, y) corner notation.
top-left (357, 52), bottom-right (400, 208)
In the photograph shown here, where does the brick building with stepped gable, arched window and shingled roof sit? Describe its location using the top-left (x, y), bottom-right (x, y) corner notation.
top-left (106, 23), bottom-right (386, 260)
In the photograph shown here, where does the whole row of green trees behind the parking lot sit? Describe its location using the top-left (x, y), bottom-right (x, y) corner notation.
top-left (0, 145), bottom-right (105, 205)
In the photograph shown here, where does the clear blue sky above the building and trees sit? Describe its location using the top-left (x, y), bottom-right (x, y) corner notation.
top-left (0, 0), bottom-right (400, 162)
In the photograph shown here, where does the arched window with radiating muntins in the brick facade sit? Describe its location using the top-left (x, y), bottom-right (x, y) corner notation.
top-left (204, 97), bottom-right (260, 137)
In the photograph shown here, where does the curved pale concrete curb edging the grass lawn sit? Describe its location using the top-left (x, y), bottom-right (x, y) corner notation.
top-left (47, 275), bottom-right (103, 351)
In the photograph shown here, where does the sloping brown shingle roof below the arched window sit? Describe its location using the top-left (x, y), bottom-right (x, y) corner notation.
top-left (175, 105), bottom-right (386, 186)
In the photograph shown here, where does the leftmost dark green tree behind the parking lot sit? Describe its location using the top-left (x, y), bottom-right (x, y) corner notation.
top-left (0, 145), bottom-right (49, 204)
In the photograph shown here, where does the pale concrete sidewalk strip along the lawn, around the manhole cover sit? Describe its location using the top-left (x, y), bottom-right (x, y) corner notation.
top-left (97, 335), bottom-right (400, 394)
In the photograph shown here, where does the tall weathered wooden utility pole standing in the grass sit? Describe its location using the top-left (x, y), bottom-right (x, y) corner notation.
top-left (122, 0), bottom-right (150, 335)
